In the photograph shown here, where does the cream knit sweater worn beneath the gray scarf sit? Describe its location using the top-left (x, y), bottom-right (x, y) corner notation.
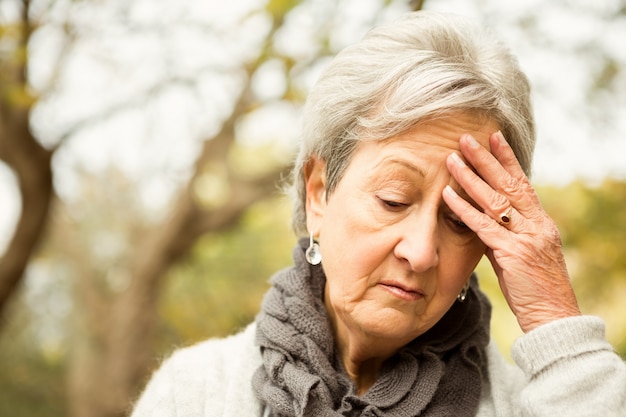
top-left (132, 316), bottom-right (626, 417)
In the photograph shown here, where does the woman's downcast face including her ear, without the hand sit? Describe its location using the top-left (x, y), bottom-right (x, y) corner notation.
top-left (307, 115), bottom-right (498, 347)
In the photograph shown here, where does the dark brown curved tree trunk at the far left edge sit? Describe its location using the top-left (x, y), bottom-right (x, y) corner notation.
top-left (0, 0), bottom-right (54, 315)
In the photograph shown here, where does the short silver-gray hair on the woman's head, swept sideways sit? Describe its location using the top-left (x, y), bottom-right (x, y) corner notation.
top-left (290, 11), bottom-right (535, 236)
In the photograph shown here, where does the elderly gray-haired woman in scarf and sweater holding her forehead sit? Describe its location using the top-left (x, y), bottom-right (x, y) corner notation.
top-left (129, 12), bottom-right (626, 417)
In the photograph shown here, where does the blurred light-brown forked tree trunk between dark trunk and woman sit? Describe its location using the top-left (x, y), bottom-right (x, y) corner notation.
top-left (68, 122), bottom-right (285, 417)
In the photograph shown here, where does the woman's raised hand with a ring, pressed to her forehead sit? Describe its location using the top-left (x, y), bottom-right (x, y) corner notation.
top-left (443, 132), bottom-right (580, 332)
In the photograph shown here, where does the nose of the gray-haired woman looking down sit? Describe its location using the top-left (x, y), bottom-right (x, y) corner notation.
top-left (394, 212), bottom-right (439, 272)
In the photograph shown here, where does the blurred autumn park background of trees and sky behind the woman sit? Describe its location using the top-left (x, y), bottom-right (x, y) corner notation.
top-left (0, 0), bottom-right (626, 417)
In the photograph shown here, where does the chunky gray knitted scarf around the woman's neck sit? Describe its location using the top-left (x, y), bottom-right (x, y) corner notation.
top-left (252, 239), bottom-right (491, 417)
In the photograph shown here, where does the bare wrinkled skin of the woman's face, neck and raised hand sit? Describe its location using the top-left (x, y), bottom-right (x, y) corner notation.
top-left (305, 114), bottom-right (580, 392)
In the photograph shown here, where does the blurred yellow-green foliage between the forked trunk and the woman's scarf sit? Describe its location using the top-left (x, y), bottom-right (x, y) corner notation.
top-left (159, 198), bottom-right (295, 350)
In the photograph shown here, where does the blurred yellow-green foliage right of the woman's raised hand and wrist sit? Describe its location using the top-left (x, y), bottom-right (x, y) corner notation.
top-left (540, 179), bottom-right (626, 357)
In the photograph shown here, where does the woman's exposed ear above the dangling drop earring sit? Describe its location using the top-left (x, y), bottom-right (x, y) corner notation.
top-left (304, 157), bottom-right (326, 236)
